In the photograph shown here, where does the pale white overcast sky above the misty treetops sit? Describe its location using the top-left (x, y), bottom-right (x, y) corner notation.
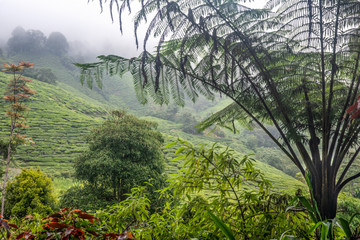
top-left (0, 0), bottom-right (265, 55)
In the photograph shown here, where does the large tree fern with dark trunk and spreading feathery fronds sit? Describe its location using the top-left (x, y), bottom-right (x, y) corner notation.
top-left (78, 0), bottom-right (360, 220)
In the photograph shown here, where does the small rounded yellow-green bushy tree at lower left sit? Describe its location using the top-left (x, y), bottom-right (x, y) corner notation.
top-left (5, 168), bottom-right (56, 218)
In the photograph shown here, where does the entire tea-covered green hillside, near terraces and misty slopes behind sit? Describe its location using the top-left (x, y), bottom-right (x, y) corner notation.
top-left (0, 54), bottom-right (303, 195)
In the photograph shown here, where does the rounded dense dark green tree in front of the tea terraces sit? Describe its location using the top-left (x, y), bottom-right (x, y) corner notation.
top-left (68, 111), bottom-right (165, 208)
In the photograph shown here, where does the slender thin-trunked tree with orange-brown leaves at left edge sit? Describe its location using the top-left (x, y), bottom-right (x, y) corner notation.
top-left (1, 61), bottom-right (36, 216)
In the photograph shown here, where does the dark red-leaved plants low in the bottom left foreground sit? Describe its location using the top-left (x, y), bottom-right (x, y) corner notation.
top-left (1, 208), bottom-right (136, 240)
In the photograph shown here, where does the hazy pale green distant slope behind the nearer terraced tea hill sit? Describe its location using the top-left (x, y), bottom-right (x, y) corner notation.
top-left (5, 52), bottom-right (148, 115)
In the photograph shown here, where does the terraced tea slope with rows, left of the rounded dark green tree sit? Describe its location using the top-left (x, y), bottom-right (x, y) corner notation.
top-left (0, 73), bottom-right (106, 176)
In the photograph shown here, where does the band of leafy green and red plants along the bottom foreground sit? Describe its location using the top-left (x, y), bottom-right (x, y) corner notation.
top-left (2, 140), bottom-right (360, 240)
